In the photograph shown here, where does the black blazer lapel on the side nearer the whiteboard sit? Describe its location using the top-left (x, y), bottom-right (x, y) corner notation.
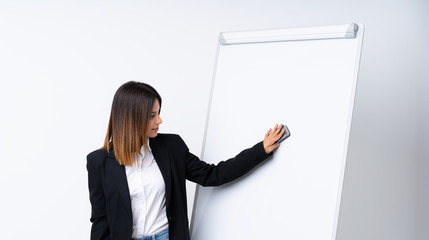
top-left (149, 138), bottom-right (171, 207)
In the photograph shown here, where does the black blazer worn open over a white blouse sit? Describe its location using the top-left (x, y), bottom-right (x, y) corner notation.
top-left (87, 134), bottom-right (269, 240)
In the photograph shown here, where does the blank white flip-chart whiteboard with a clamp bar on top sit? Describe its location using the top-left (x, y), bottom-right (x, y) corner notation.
top-left (191, 24), bottom-right (364, 240)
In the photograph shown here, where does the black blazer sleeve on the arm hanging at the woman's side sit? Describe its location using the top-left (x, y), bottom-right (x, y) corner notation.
top-left (86, 154), bottom-right (110, 240)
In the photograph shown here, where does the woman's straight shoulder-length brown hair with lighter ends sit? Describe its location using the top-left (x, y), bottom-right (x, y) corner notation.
top-left (101, 81), bottom-right (162, 166)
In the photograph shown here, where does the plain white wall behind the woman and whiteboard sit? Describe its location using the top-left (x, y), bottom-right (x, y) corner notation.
top-left (0, 0), bottom-right (429, 240)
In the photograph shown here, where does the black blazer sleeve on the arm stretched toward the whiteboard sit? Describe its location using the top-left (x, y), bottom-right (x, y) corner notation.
top-left (182, 137), bottom-right (272, 186)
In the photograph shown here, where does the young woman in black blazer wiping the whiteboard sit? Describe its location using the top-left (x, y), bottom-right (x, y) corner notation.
top-left (87, 82), bottom-right (284, 240)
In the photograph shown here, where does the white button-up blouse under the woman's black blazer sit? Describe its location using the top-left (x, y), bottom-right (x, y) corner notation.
top-left (125, 142), bottom-right (168, 238)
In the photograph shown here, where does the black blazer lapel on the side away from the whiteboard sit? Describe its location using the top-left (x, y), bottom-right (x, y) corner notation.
top-left (107, 152), bottom-right (132, 215)
